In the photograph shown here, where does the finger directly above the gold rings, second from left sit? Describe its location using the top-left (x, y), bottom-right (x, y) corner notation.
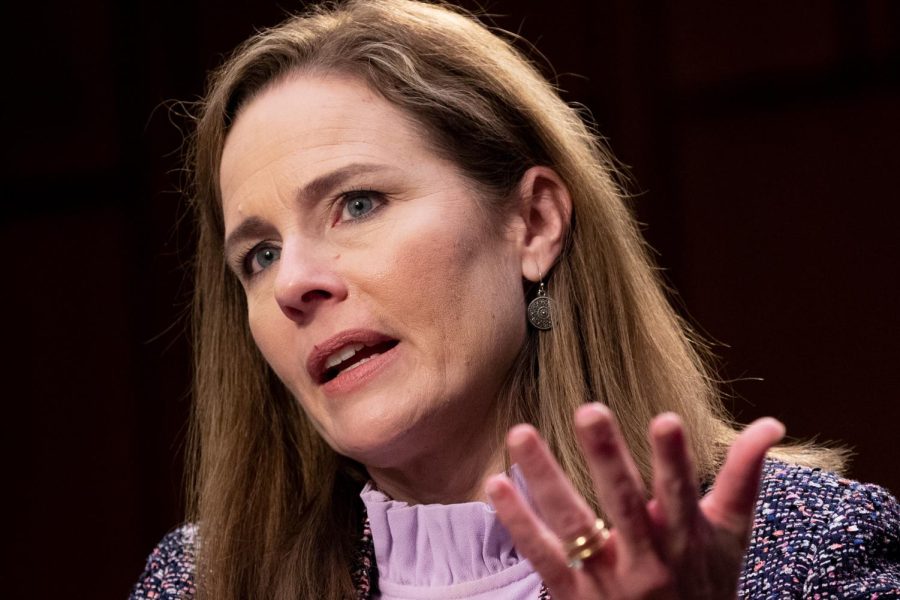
top-left (507, 425), bottom-right (596, 540)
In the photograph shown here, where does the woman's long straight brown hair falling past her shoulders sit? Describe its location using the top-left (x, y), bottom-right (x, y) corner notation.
top-left (183, 0), bottom-right (840, 600)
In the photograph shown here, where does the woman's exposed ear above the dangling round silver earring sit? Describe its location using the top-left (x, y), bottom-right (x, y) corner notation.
top-left (517, 167), bottom-right (572, 281)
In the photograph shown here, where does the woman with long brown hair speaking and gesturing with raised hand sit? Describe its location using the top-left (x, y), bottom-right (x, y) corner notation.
top-left (133, 0), bottom-right (900, 599)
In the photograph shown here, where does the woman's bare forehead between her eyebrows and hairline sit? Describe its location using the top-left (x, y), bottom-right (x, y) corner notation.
top-left (220, 73), bottom-right (432, 204)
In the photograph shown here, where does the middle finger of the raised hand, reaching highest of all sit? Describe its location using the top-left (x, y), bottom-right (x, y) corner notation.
top-left (575, 403), bottom-right (653, 550)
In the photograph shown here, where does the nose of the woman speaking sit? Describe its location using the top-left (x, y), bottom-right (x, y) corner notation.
top-left (275, 243), bottom-right (347, 323)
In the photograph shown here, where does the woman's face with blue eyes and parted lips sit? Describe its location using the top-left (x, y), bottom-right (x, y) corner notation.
top-left (221, 75), bottom-right (525, 467)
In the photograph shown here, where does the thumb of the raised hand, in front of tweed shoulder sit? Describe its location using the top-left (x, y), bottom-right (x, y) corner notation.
top-left (700, 417), bottom-right (784, 535)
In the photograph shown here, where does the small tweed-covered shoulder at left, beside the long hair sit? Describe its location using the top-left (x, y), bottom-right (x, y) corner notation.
top-left (130, 524), bottom-right (197, 600)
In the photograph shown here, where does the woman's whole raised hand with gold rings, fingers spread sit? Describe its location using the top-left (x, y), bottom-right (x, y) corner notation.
top-left (487, 404), bottom-right (784, 600)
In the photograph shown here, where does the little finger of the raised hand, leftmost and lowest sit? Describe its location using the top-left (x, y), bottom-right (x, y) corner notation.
top-left (486, 475), bottom-right (575, 597)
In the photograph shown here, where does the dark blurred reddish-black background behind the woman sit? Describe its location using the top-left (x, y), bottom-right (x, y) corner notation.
top-left (0, 0), bottom-right (900, 598)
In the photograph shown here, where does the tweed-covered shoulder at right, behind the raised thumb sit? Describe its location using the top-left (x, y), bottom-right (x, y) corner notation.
top-left (741, 460), bottom-right (900, 598)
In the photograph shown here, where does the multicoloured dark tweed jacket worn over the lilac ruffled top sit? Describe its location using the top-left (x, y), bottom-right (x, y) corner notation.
top-left (130, 460), bottom-right (900, 600)
